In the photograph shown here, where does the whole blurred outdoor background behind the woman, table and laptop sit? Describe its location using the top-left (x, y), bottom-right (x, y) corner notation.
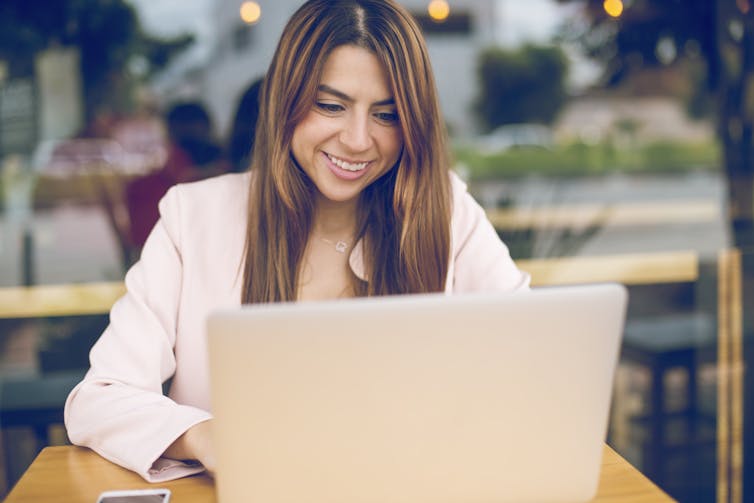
top-left (0, 0), bottom-right (754, 502)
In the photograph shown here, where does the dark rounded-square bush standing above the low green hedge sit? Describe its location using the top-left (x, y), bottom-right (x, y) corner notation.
top-left (474, 45), bottom-right (568, 130)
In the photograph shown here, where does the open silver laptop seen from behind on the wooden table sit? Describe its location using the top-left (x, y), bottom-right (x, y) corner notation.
top-left (203, 284), bottom-right (627, 503)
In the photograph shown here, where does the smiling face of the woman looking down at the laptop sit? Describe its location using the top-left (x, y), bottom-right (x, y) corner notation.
top-left (291, 45), bottom-right (403, 203)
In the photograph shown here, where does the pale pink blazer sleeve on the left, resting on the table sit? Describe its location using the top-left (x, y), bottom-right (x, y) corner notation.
top-left (65, 184), bottom-right (211, 482)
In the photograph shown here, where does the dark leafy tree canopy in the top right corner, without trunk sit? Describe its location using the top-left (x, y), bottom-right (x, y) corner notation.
top-left (556, 0), bottom-right (724, 117)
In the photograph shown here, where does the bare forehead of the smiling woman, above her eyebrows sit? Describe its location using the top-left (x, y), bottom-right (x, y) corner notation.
top-left (320, 45), bottom-right (393, 101)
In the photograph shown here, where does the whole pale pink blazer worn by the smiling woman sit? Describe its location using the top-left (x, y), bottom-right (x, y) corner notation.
top-left (65, 173), bottom-right (529, 482)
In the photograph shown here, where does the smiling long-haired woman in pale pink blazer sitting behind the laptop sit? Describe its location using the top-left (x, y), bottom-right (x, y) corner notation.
top-left (66, 0), bottom-right (528, 481)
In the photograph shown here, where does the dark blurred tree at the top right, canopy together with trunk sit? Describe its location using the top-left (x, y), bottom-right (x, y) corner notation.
top-left (557, 0), bottom-right (754, 247)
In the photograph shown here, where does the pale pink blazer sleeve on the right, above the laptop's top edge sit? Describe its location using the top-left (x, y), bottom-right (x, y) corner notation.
top-left (449, 173), bottom-right (531, 293)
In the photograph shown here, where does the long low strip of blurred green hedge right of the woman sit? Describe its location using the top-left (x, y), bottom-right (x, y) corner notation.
top-left (455, 141), bottom-right (720, 180)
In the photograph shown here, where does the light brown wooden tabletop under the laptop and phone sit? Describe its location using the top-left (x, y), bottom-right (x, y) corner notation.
top-left (5, 446), bottom-right (673, 503)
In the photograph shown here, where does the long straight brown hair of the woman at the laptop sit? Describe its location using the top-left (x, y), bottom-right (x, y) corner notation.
top-left (241, 0), bottom-right (451, 303)
